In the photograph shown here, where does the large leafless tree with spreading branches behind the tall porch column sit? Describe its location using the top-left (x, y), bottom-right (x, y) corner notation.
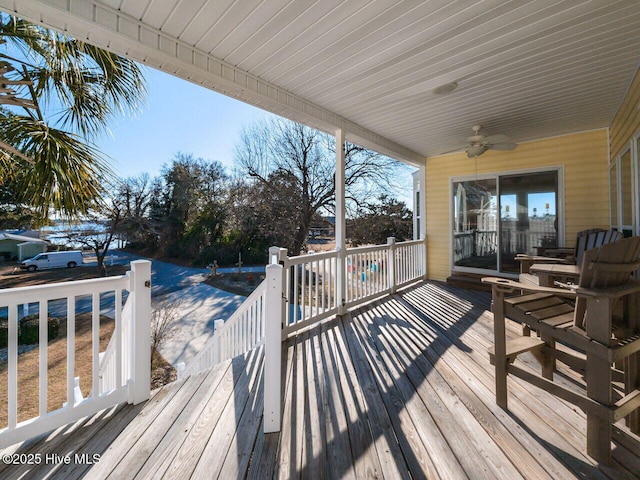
top-left (235, 118), bottom-right (399, 255)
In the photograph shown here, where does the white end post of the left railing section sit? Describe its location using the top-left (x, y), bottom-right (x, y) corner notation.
top-left (129, 260), bottom-right (151, 405)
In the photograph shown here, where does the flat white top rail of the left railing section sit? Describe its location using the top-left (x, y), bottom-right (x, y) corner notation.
top-left (0, 272), bottom-right (130, 305)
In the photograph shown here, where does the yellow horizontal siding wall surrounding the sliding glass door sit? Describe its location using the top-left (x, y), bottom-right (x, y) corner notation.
top-left (426, 130), bottom-right (609, 280)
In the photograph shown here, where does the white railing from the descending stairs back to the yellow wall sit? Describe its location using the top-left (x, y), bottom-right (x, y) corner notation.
top-left (179, 238), bottom-right (427, 432)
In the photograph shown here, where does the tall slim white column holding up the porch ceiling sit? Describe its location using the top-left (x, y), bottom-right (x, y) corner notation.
top-left (335, 129), bottom-right (347, 315)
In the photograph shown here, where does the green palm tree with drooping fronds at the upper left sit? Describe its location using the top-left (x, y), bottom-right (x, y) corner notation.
top-left (0, 14), bottom-right (145, 221)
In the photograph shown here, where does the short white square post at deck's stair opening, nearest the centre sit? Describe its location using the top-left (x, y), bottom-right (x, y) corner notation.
top-left (264, 263), bottom-right (283, 433)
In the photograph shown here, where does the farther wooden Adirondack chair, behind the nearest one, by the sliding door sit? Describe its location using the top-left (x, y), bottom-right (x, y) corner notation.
top-left (516, 228), bottom-right (624, 283)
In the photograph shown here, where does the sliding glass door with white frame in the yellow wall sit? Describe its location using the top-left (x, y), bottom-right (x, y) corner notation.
top-left (452, 170), bottom-right (559, 273)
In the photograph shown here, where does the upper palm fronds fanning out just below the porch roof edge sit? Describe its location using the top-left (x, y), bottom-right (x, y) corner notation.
top-left (0, 14), bottom-right (146, 138)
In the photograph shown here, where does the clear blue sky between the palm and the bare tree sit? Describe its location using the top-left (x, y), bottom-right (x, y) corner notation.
top-left (97, 68), bottom-right (270, 177)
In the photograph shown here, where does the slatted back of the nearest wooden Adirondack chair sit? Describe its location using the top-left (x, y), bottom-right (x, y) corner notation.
top-left (574, 237), bottom-right (640, 328)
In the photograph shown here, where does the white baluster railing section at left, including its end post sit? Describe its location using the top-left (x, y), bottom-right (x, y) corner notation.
top-left (0, 260), bottom-right (151, 449)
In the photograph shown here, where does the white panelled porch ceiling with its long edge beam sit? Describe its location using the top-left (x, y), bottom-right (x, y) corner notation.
top-left (5, 0), bottom-right (640, 165)
